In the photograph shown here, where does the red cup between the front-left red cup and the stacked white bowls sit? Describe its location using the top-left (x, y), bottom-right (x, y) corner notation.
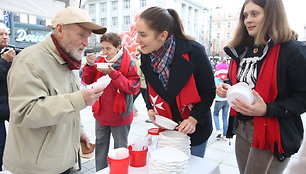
top-left (128, 146), bottom-right (148, 167)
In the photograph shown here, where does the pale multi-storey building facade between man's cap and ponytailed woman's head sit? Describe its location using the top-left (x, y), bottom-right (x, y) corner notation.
top-left (82, 0), bottom-right (206, 48)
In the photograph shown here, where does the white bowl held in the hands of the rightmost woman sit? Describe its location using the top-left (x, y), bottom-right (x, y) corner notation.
top-left (226, 82), bottom-right (255, 106)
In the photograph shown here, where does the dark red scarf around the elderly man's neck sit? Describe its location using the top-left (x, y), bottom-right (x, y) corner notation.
top-left (51, 34), bottom-right (81, 70)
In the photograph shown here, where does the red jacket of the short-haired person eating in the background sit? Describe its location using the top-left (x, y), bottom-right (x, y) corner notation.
top-left (82, 50), bottom-right (140, 126)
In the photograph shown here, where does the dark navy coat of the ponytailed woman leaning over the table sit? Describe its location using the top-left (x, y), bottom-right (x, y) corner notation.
top-left (141, 38), bottom-right (216, 146)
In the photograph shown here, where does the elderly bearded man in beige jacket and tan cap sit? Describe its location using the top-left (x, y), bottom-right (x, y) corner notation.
top-left (4, 7), bottom-right (106, 174)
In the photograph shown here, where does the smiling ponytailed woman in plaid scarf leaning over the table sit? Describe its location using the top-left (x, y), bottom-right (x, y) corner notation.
top-left (136, 7), bottom-right (215, 157)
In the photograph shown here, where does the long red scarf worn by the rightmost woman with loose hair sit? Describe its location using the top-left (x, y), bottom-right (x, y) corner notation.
top-left (229, 44), bottom-right (284, 153)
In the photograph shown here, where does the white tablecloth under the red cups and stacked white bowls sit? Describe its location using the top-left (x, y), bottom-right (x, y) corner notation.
top-left (96, 155), bottom-right (220, 174)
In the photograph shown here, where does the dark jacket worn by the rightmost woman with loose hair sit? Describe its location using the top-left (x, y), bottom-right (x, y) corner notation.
top-left (224, 40), bottom-right (306, 161)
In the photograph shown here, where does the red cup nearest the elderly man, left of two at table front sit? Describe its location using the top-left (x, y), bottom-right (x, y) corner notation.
top-left (107, 157), bottom-right (129, 174)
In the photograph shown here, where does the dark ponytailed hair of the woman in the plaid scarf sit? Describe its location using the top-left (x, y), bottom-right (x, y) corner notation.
top-left (139, 7), bottom-right (193, 40)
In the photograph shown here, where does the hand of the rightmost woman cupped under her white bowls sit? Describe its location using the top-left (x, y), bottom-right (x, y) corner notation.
top-left (232, 90), bottom-right (267, 116)
